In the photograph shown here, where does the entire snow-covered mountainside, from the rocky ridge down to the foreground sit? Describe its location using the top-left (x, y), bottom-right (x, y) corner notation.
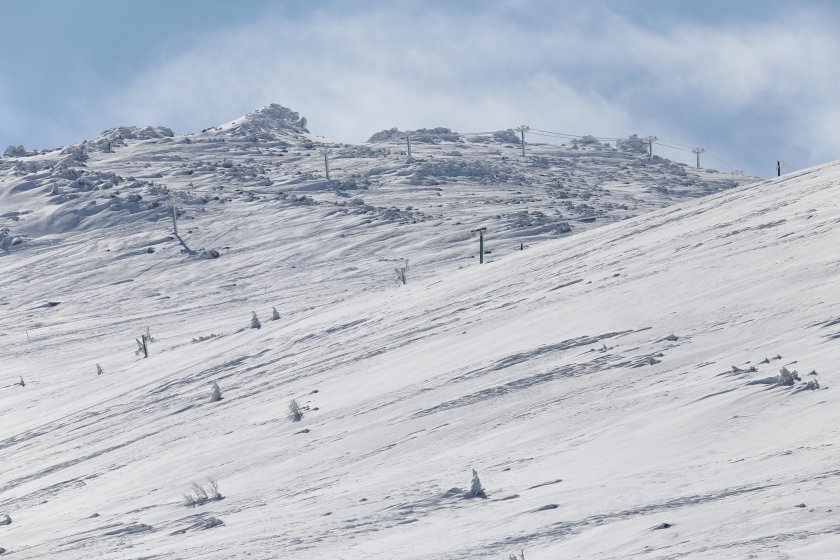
top-left (0, 107), bottom-right (840, 560)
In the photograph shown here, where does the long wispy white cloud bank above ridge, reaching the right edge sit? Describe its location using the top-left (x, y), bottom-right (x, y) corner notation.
top-left (54, 2), bottom-right (840, 174)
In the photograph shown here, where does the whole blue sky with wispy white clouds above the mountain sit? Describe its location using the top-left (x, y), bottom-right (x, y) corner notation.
top-left (0, 0), bottom-right (840, 177)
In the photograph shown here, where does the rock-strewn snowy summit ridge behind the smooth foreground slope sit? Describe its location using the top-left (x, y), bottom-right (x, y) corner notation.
top-left (0, 104), bottom-right (755, 255)
